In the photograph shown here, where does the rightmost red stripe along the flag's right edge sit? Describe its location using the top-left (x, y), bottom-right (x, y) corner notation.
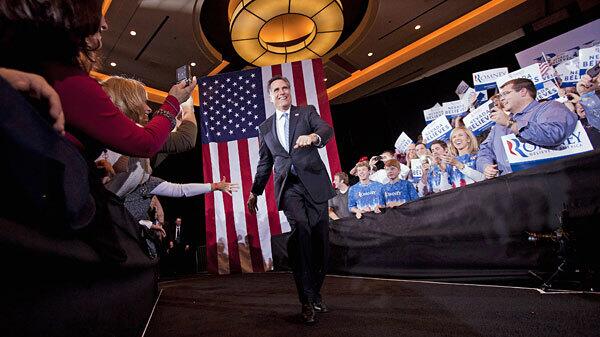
top-left (312, 59), bottom-right (342, 176)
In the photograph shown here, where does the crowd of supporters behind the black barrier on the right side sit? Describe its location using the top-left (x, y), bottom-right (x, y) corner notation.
top-left (329, 75), bottom-right (600, 220)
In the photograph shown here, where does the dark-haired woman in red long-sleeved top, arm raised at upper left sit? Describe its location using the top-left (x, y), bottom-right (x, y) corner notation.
top-left (0, 0), bottom-right (196, 163)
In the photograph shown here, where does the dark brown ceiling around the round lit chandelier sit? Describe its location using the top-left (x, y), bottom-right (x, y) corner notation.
top-left (101, 0), bottom-right (598, 103)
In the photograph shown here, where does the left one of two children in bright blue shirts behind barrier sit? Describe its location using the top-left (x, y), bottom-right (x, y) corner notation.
top-left (348, 161), bottom-right (385, 219)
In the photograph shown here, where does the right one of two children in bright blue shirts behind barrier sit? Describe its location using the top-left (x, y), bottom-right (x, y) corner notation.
top-left (383, 159), bottom-right (419, 208)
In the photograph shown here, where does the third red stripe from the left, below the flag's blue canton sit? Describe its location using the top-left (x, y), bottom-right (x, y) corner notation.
top-left (238, 139), bottom-right (265, 272)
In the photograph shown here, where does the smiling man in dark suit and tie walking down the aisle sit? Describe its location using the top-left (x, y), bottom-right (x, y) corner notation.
top-left (248, 76), bottom-right (334, 324)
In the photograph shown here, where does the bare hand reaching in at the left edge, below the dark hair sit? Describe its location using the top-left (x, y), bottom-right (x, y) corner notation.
top-left (0, 68), bottom-right (65, 135)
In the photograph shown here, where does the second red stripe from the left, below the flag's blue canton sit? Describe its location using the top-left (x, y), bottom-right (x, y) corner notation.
top-left (217, 142), bottom-right (242, 273)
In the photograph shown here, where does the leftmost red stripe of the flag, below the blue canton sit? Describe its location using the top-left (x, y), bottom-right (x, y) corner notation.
top-left (202, 144), bottom-right (219, 274)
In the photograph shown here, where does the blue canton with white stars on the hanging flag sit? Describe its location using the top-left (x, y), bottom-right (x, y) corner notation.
top-left (200, 68), bottom-right (266, 144)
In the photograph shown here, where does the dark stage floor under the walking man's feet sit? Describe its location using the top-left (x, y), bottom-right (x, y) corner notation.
top-left (145, 273), bottom-right (600, 337)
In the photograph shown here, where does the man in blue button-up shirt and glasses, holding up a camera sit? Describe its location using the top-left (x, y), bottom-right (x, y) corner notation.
top-left (477, 78), bottom-right (577, 179)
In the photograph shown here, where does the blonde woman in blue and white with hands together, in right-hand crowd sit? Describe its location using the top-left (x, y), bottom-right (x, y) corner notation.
top-left (442, 126), bottom-right (485, 188)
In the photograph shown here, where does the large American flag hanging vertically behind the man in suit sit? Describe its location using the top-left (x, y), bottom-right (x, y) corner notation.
top-left (199, 59), bottom-right (341, 274)
